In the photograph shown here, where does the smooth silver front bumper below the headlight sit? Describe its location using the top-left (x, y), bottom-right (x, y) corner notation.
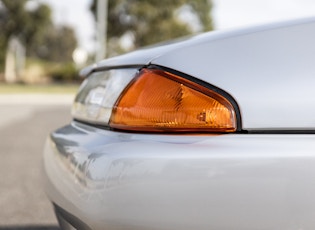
top-left (44, 122), bottom-right (315, 230)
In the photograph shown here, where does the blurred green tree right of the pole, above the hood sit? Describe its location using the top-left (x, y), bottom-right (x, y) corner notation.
top-left (91, 0), bottom-right (213, 55)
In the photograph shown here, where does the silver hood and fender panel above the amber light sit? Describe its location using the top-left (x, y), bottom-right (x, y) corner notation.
top-left (82, 18), bottom-right (315, 130)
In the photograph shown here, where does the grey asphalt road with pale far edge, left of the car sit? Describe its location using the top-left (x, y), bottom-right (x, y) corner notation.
top-left (0, 95), bottom-right (71, 230)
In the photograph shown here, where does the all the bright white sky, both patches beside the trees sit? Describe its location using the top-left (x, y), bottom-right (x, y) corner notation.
top-left (38, 0), bottom-right (315, 51)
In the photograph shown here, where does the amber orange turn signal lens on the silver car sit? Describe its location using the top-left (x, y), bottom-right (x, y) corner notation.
top-left (109, 69), bottom-right (236, 132)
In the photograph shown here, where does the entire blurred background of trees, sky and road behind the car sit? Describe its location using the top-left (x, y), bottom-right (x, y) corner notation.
top-left (0, 0), bottom-right (315, 230)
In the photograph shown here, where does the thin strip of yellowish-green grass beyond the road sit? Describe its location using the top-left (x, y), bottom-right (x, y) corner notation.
top-left (0, 83), bottom-right (79, 94)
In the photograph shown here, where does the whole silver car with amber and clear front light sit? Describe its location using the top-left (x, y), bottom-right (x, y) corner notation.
top-left (44, 18), bottom-right (315, 230)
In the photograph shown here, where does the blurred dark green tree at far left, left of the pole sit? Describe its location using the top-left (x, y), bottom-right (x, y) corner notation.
top-left (0, 0), bottom-right (77, 70)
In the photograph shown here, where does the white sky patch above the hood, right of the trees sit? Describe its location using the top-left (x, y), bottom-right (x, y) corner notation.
top-left (212, 0), bottom-right (315, 29)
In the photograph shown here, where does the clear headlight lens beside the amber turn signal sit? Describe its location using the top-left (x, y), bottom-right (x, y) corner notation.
top-left (72, 68), bottom-right (137, 125)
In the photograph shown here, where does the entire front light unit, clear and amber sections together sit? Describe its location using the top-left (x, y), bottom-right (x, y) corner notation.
top-left (73, 66), bottom-right (237, 132)
